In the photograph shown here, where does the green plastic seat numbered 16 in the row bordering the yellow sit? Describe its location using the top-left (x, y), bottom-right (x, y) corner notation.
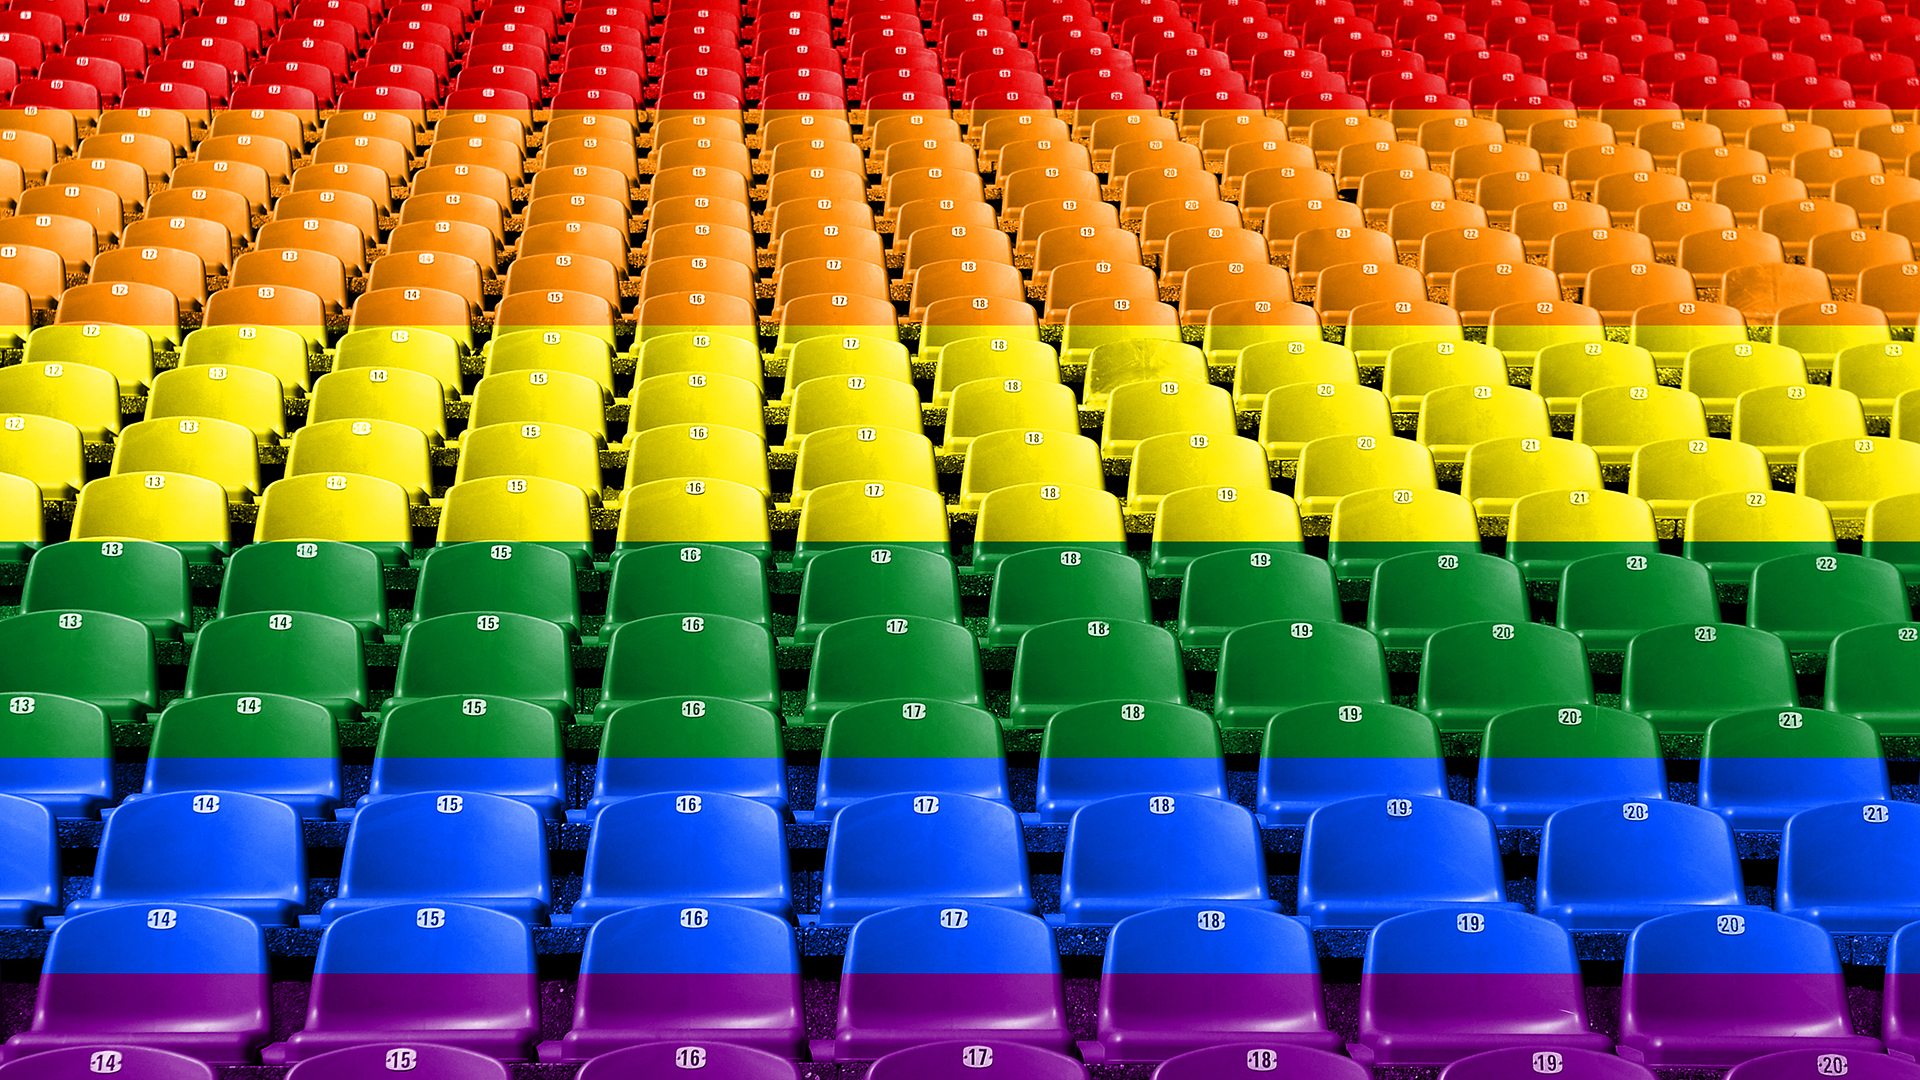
top-left (601, 544), bottom-right (774, 640)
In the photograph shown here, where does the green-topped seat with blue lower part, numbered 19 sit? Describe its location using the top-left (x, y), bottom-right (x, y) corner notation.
top-left (1258, 701), bottom-right (1446, 824)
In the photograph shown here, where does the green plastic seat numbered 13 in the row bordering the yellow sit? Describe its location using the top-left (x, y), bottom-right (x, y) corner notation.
top-left (21, 540), bottom-right (192, 638)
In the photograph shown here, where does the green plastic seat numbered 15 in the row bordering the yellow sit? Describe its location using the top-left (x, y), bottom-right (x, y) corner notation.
top-left (413, 542), bottom-right (580, 636)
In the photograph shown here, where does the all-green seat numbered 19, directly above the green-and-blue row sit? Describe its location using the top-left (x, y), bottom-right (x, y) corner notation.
top-left (1213, 619), bottom-right (1386, 730)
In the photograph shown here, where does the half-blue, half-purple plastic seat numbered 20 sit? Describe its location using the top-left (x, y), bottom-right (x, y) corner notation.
top-left (1619, 907), bottom-right (1880, 1068)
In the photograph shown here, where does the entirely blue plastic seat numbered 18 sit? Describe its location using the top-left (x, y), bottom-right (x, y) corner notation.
top-left (1060, 794), bottom-right (1279, 922)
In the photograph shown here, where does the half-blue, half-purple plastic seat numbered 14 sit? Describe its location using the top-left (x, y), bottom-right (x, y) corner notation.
top-left (4, 903), bottom-right (271, 1065)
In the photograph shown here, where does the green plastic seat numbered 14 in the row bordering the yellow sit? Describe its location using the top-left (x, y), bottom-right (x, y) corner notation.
top-left (219, 540), bottom-right (386, 640)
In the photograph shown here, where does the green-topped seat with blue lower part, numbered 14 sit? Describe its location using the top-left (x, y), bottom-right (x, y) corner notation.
top-left (140, 694), bottom-right (340, 821)
